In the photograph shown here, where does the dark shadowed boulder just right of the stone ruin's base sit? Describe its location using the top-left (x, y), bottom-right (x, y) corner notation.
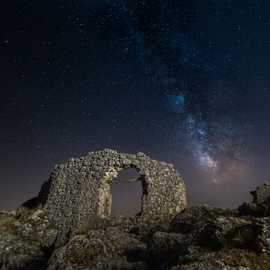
top-left (170, 206), bottom-right (255, 250)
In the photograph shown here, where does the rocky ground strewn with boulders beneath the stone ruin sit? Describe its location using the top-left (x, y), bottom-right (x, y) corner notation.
top-left (0, 184), bottom-right (270, 270)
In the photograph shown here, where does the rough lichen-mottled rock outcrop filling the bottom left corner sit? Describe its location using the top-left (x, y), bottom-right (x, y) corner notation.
top-left (0, 208), bottom-right (57, 270)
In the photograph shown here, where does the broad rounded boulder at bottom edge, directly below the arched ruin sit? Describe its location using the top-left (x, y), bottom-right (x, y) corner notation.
top-left (48, 228), bottom-right (146, 270)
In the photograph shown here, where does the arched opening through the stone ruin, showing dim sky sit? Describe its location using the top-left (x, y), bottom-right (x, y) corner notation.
top-left (111, 168), bottom-right (143, 216)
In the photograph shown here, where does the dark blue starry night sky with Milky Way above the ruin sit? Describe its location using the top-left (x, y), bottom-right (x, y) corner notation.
top-left (0, 0), bottom-right (270, 208)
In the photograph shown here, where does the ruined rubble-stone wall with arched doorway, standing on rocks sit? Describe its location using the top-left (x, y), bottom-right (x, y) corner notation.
top-left (45, 149), bottom-right (187, 231)
